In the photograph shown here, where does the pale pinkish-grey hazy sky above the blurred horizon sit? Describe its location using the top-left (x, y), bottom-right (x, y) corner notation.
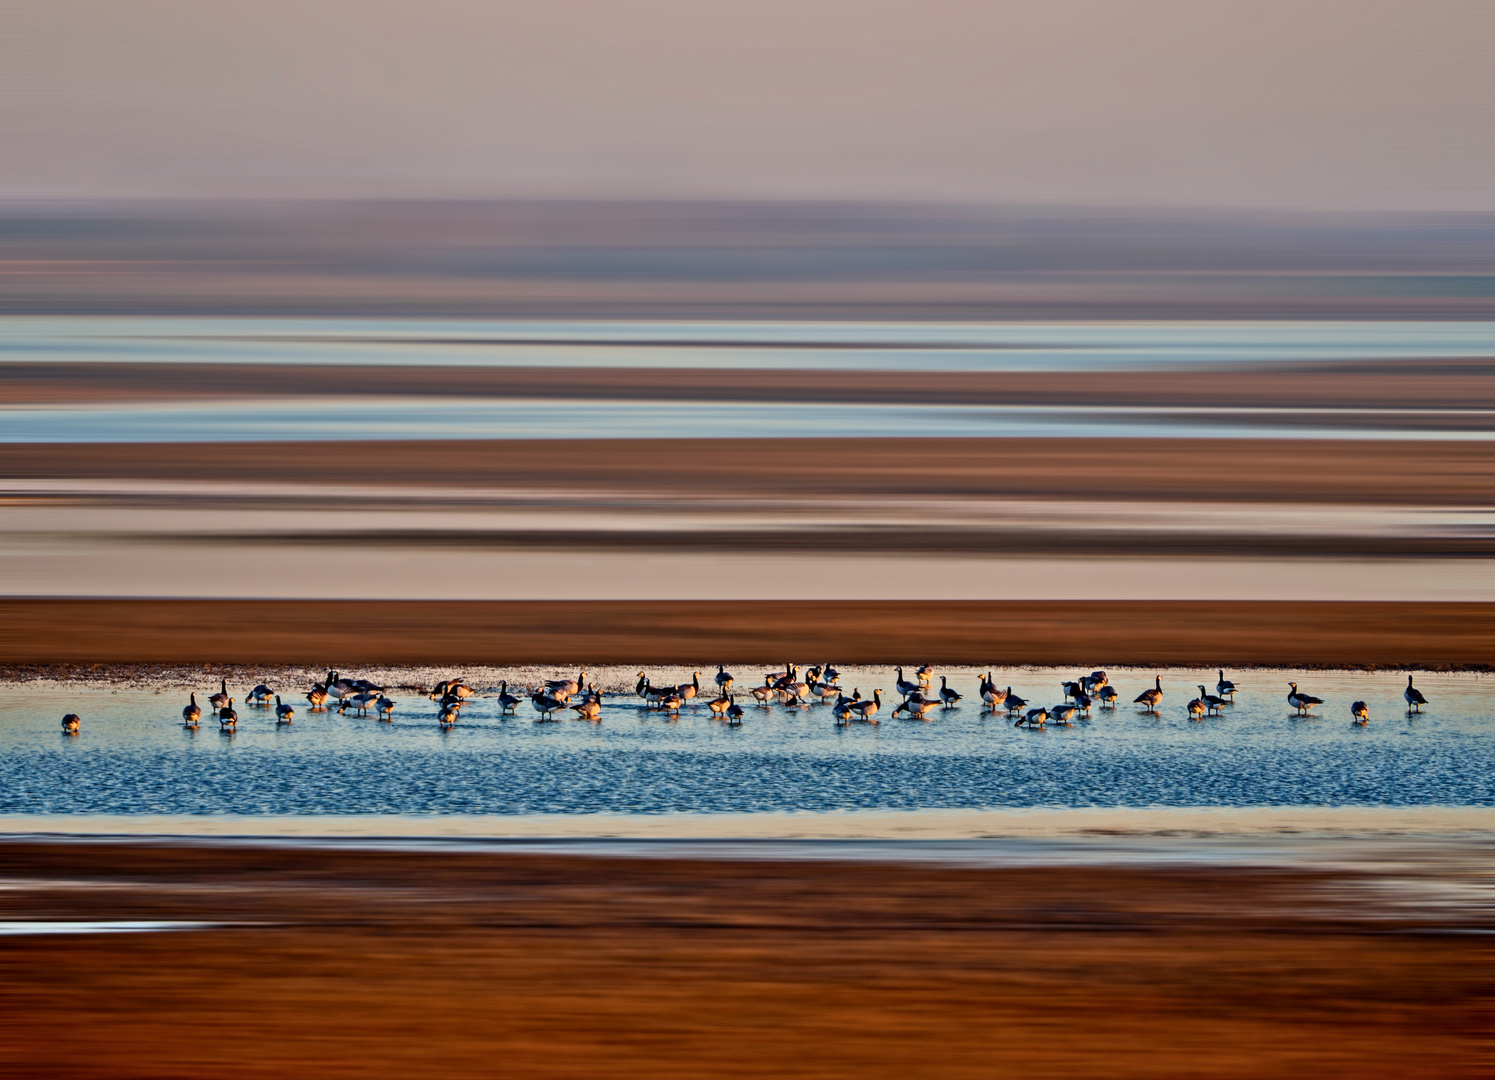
top-left (0, 0), bottom-right (1495, 211)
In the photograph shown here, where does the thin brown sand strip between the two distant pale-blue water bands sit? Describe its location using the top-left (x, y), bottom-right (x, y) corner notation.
top-left (0, 361), bottom-right (1495, 413)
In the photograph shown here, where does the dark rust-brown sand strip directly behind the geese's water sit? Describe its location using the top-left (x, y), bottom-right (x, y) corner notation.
top-left (0, 598), bottom-right (1495, 670)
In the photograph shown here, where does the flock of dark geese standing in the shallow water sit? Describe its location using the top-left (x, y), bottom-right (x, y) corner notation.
top-left (63, 664), bottom-right (1428, 734)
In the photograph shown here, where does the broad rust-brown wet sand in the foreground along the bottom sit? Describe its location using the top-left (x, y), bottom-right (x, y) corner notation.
top-left (0, 842), bottom-right (1491, 1080)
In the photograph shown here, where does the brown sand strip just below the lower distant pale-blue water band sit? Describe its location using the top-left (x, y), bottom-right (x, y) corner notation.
top-left (0, 438), bottom-right (1495, 506)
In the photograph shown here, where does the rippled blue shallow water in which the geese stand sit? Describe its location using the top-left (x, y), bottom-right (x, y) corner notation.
top-left (0, 670), bottom-right (1495, 814)
